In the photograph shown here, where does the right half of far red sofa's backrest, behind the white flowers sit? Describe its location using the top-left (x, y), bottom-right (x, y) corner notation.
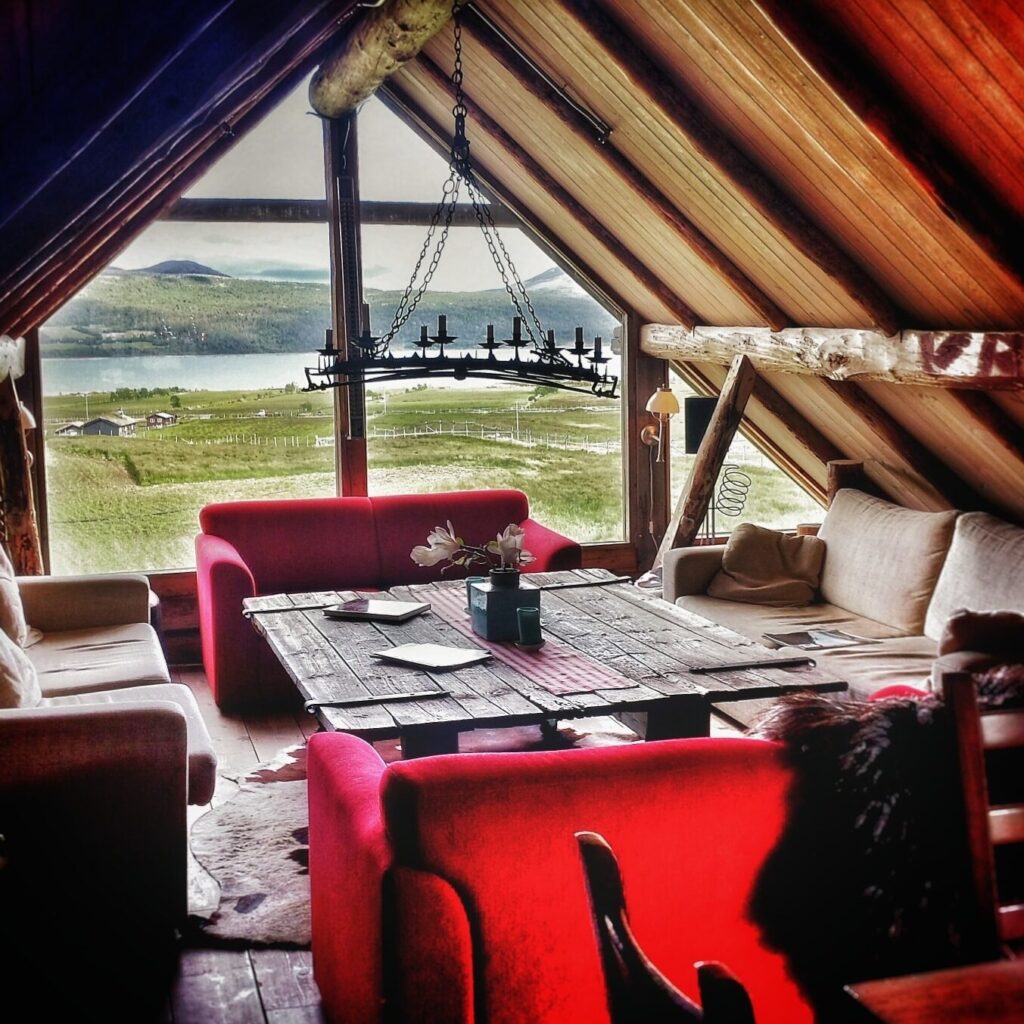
top-left (370, 490), bottom-right (529, 589)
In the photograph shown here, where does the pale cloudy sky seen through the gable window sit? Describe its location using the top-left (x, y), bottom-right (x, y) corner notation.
top-left (114, 83), bottom-right (552, 291)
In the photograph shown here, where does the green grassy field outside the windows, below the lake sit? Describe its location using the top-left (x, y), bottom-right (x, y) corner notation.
top-left (45, 385), bottom-right (820, 572)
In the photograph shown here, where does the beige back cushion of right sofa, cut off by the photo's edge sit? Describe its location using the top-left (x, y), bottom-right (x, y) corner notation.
top-left (925, 512), bottom-right (1024, 640)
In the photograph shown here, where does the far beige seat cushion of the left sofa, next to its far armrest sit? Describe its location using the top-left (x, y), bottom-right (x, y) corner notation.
top-left (26, 623), bottom-right (171, 697)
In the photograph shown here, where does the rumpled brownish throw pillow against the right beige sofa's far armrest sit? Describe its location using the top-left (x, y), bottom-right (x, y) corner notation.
top-left (708, 522), bottom-right (825, 607)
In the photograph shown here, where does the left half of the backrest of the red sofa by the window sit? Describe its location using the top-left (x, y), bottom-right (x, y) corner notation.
top-left (199, 498), bottom-right (380, 594)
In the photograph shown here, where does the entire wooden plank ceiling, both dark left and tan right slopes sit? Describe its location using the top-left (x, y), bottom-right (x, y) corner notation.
top-left (0, 0), bottom-right (1024, 520)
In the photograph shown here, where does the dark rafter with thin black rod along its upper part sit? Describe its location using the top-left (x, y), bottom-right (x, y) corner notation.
top-left (463, 8), bottom-right (794, 331)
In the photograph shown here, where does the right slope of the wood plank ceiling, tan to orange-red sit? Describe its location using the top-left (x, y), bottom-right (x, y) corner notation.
top-left (391, 0), bottom-right (1024, 519)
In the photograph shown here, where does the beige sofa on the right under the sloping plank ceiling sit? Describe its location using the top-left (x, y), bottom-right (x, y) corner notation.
top-left (664, 489), bottom-right (1024, 697)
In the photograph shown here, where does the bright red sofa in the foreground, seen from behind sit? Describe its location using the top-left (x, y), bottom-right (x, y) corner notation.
top-left (309, 733), bottom-right (812, 1024)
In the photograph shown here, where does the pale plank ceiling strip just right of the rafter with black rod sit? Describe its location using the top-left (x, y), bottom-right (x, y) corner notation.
top-left (486, 0), bottom-right (867, 327)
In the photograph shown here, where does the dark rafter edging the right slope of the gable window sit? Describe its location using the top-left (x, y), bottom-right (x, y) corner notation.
top-left (378, 79), bottom-right (629, 315)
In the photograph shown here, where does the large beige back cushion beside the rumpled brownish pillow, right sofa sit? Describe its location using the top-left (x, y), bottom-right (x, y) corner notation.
top-left (818, 488), bottom-right (958, 634)
